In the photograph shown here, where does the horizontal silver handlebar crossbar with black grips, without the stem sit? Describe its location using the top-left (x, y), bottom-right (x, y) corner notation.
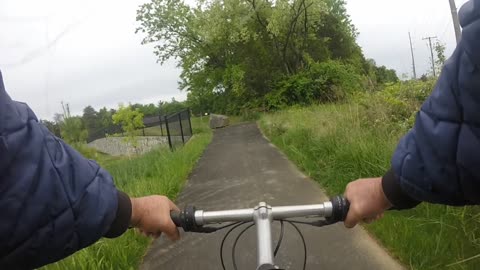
top-left (171, 196), bottom-right (350, 232)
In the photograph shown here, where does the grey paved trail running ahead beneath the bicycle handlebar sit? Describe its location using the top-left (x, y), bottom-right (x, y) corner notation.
top-left (141, 124), bottom-right (402, 270)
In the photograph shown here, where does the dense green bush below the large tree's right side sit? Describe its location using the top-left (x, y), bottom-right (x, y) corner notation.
top-left (266, 61), bottom-right (361, 110)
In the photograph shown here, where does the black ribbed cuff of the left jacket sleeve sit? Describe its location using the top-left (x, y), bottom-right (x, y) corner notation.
top-left (104, 190), bottom-right (132, 238)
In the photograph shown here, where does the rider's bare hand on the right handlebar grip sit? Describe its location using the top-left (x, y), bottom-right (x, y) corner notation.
top-left (344, 178), bottom-right (392, 228)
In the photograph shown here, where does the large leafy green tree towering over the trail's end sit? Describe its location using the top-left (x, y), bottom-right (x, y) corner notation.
top-left (137, 0), bottom-right (365, 113)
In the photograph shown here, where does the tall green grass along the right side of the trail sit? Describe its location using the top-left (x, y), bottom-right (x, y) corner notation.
top-left (259, 104), bottom-right (480, 269)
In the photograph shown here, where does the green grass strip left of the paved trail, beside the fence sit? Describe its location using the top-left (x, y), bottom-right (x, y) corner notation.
top-left (42, 119), bottom-right (212, 270)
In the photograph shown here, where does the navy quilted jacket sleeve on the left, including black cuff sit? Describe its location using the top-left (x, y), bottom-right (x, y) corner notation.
top-left (0, 70), bottom-right (131, 269)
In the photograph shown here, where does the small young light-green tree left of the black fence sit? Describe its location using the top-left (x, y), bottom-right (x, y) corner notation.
top-left (112, 104), bottom-right (144, 147)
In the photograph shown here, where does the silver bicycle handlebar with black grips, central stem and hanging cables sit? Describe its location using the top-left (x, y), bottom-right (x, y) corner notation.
top-left (170, 196), bottom-right (350, 270)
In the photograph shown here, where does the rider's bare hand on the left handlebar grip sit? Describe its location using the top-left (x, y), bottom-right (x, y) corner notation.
top-left (130, 196), bottom-right (180, 241)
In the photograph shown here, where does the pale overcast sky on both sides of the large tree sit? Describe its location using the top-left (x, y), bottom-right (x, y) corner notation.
top-left (0, 0), bottom-right (467, 118)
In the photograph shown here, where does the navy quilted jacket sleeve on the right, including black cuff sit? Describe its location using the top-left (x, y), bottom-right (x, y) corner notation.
top-left (382, 0), bottom-right (480, 209)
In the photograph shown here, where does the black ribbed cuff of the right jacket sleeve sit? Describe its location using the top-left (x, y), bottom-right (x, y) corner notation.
top-left (382, 169), bottom-right (420, 210)
